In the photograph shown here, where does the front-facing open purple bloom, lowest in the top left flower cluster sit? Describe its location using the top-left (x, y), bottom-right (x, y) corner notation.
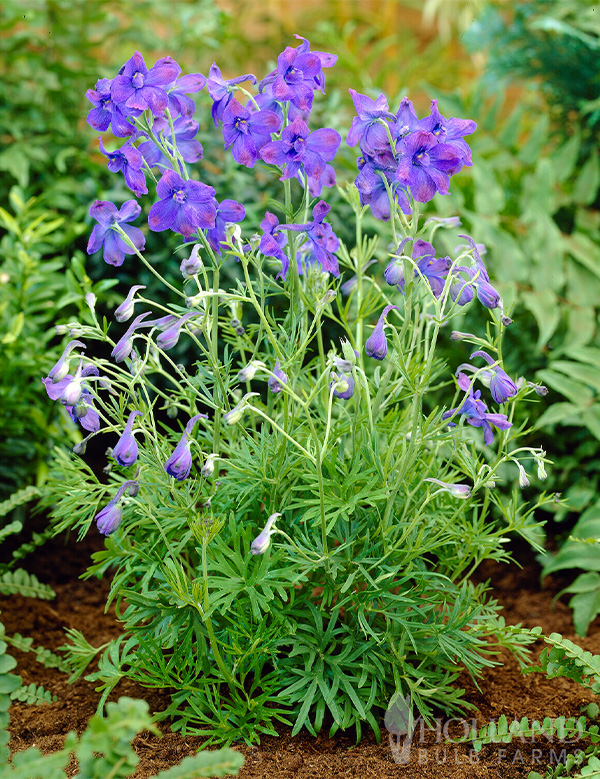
top-left (148, 170), bottom-right (217, 238)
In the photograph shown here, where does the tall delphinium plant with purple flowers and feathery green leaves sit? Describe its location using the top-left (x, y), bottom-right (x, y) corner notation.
top-left (43, 38), bottom-right (547, 741)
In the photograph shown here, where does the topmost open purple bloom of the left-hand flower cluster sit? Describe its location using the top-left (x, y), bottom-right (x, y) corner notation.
top-left (111, 51), bottom-right (181, 116)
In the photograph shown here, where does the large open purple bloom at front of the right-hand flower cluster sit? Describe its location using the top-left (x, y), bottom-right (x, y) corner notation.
top-left (396, 130), bottom-right (461, 203)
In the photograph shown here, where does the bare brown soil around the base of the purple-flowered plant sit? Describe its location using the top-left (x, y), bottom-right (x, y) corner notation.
top-left (0, 534), bottom-right (600, 779)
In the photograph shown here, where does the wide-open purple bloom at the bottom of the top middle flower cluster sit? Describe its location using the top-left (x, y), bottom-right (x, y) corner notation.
top-left (260, 118), bottom-right (341, 181)
